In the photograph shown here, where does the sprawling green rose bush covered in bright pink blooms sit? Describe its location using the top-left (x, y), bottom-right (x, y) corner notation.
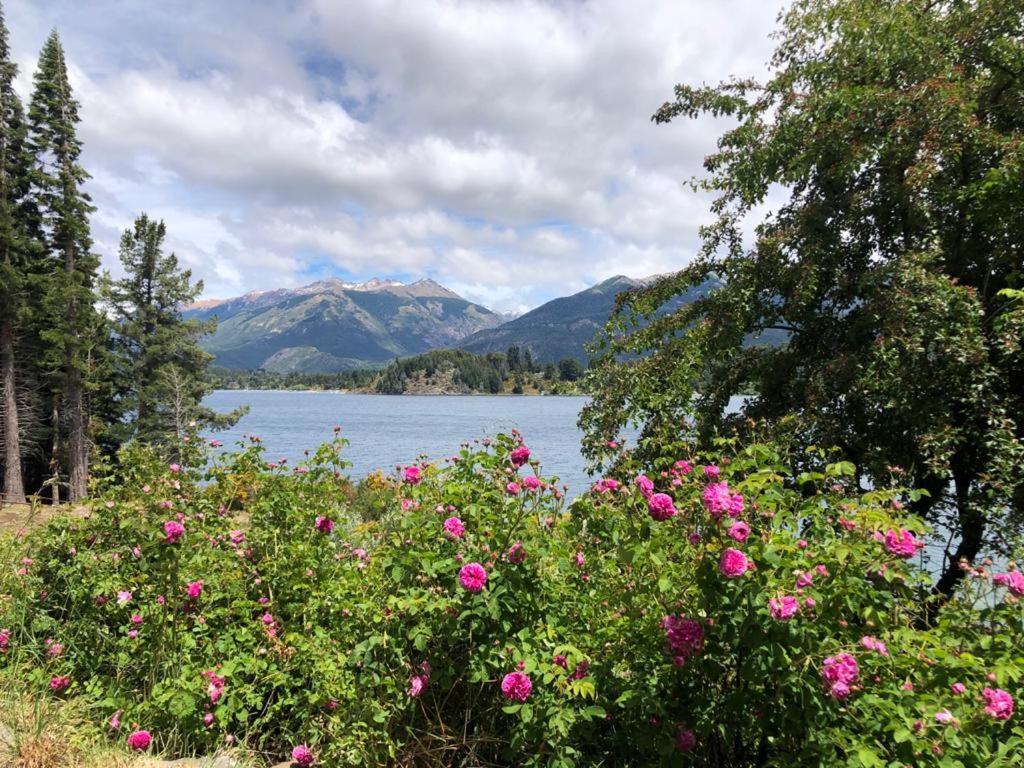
top-left (0, 434), bottom-right (1024, 766)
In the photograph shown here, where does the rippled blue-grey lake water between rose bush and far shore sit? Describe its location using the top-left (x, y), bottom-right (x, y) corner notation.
top-left (204, 390), bottom-right (590, 493)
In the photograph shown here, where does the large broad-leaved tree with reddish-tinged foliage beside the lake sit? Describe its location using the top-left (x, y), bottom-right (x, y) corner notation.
top-left (583, 0), bottom-right (1024, 594)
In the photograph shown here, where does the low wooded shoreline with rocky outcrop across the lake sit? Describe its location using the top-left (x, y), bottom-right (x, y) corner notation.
top-left (211, 346), bottom-right (584, 394)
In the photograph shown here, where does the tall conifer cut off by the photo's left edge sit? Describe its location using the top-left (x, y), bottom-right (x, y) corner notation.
top-left (0, 7), bottom-right (34, 503)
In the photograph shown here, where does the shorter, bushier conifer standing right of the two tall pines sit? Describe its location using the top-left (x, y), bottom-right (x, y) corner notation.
top-left (102, 213), bottom-right (243, 442)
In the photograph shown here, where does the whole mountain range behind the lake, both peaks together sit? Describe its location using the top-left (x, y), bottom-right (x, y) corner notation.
top-left (183, 275), bottom-right (703, 373)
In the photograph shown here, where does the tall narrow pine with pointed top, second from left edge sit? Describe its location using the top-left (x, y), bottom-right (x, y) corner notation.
top-left (29, 32), bottom-right (102, 501)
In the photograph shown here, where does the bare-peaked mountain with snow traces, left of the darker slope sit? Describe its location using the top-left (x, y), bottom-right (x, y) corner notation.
top-left (184, 280), bottom-right (501, 373)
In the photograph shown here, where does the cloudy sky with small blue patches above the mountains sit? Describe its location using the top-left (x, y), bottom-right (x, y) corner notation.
top-left (3, 0), bottom-right (783, 312)
